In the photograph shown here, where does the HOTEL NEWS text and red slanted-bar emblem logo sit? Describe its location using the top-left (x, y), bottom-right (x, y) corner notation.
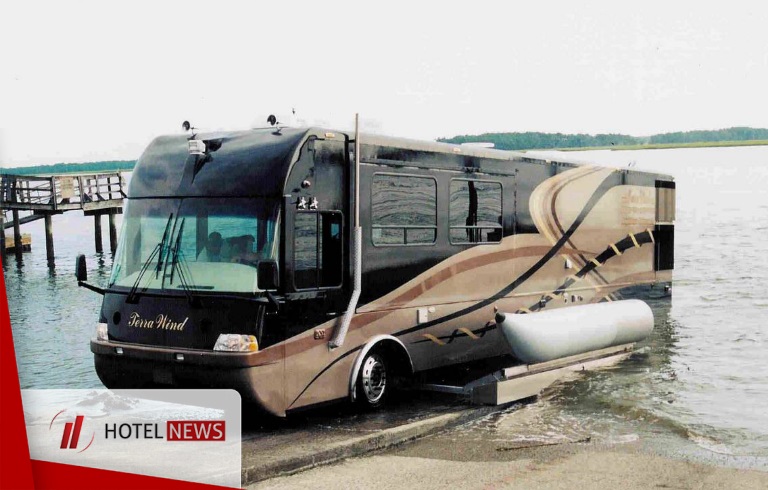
top-left (48, 410), bottom-right (227, 453)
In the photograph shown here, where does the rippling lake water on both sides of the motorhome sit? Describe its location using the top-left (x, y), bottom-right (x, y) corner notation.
top-left (3, 147), bottom-right (768, 470)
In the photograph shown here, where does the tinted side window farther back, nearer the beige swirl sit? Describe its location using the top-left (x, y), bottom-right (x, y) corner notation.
top-left (450, 179), bottom-right (502, 244)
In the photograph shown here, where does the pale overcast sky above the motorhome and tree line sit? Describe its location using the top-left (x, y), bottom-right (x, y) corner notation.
top-left (0, 0), bottom-right (768, 166)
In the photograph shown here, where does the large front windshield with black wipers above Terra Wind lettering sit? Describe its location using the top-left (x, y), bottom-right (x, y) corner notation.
top-left (109, 198), bottom-right (279, 293)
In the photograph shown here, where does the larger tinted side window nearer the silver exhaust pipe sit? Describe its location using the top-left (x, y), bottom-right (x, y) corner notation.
top-left (371, 174), bottom-right (437, 245)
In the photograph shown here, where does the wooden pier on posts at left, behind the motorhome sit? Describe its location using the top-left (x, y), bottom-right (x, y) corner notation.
top-left (0, 172), bottom-right (125, 262)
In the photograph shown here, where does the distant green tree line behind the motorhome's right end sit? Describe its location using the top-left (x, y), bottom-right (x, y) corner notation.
top-left (438, 127), bottom-right (768, 150)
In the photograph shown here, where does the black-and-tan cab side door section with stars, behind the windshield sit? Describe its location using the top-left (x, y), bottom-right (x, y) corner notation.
top-left (283, 133), bottom-right (350, 408)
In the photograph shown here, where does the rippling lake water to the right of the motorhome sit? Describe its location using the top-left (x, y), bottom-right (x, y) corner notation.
top-left (520, 146), bottom-right (768, 470)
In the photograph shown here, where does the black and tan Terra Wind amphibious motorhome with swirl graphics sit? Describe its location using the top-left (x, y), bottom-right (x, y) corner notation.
top-left (77, 123), bottom-right (675, 416)
